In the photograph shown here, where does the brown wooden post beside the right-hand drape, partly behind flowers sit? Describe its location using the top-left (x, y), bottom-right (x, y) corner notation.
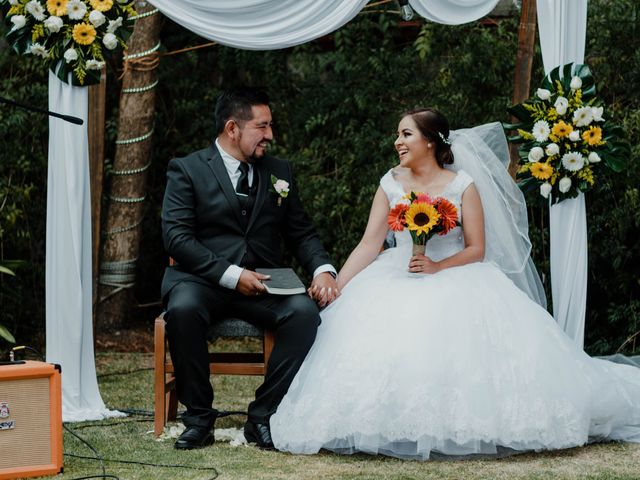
top-left (509, 0), bottom-right (536, 177)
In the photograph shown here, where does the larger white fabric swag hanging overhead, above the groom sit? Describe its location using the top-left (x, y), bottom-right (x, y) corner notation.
top-left (143, 0), bottom-right (368, 50)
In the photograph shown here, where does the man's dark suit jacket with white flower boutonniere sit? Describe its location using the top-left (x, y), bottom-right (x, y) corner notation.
top-left (162, 145), bottom-right (330, 297)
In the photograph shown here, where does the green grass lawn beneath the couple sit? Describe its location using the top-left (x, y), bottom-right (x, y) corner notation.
top-left (42, 353), bottom-right (640, 480)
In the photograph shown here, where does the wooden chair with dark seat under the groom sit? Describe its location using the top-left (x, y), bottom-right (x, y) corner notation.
top-left (153, 313), bottom-right (274, 437)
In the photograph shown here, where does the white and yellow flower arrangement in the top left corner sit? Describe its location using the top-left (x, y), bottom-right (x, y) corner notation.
top-left (0, 0), bottom-right (136, 85)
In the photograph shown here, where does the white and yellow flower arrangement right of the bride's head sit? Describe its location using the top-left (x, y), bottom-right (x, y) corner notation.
top-left (504, 64), bottom-right (630, 203)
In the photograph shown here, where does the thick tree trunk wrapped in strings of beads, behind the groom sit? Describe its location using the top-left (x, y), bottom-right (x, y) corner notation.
top-left (97, 1), bottom-right (162, 331)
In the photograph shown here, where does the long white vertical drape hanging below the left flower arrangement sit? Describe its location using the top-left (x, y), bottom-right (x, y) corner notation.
top-left (45, 72), bottom-right (119, 422)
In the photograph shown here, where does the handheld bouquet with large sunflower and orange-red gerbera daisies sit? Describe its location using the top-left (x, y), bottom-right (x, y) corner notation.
top-left (387, 192), bottom-right (460, 255)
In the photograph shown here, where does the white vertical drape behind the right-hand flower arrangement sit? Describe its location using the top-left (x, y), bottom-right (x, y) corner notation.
top-left (537, 0), bottom-right (587, 347)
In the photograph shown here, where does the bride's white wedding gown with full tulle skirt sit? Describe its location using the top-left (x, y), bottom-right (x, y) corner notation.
top-left (270, 167), bottom-right (640, 459)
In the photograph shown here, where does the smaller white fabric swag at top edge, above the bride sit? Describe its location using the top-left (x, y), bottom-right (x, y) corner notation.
top-left (409, 0), bottom-right (499, 25)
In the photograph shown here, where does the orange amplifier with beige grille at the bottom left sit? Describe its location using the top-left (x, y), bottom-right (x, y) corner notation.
top-left (0, 361), bottom-right (62, 479)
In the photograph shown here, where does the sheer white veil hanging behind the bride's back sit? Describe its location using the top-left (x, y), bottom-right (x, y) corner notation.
top-left (449, 122), bottom-right (547, 308)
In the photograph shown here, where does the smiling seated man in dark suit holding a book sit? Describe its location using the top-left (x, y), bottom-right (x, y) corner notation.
top-left (162, 88), bottom-right (338, 449)
